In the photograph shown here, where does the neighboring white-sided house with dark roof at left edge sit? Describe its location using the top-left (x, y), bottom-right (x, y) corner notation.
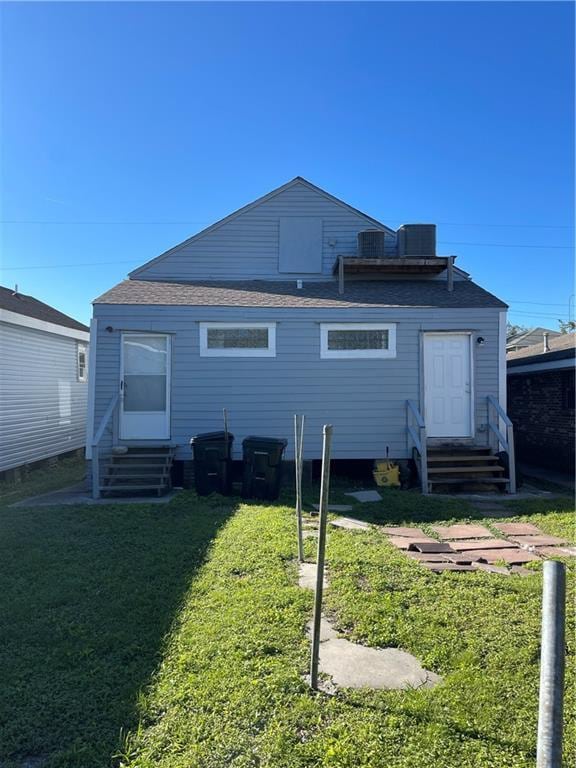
top-left (0, 286), bottom-right (90, 472)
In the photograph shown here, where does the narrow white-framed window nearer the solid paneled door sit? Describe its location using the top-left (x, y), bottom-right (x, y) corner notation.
top-left (320, 323), bottom-right (396, 359)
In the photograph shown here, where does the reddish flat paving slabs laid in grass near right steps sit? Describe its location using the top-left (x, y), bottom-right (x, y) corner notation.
top-left (379, 523), bottom-right (576, 576)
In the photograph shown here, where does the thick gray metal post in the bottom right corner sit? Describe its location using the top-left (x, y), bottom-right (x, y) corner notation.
top-left (536, 560), bottom-right (566, 768)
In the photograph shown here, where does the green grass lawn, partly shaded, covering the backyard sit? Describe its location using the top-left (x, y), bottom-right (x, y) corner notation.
top-left (0, 474), bottom-right (576, 768)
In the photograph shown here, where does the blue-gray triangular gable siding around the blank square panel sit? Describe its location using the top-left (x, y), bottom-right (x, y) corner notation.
top-left (135, 184), bottom-right (396, 280)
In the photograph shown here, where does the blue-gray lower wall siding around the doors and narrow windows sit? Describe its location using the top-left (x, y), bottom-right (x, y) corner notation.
top-left (95, 305), bottom-right (499, 459)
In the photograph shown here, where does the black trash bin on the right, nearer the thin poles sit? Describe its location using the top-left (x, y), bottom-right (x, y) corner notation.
top-left (242, 436), bottom-right (288, 500)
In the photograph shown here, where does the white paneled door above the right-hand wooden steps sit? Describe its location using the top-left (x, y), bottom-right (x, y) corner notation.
top-left (424, 333), bottom-right (472, 437)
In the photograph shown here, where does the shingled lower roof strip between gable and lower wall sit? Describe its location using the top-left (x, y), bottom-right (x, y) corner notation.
top-left (94, 280), bottom-right (506, 308)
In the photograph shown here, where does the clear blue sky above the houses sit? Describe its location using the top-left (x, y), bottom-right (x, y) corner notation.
top-left (0, 2), bottom-right (574, 327)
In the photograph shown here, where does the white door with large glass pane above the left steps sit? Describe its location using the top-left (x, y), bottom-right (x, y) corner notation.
top-left (120, 333), bottom-right (170, 440)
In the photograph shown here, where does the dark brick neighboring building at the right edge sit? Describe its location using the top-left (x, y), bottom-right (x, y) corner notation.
top-left (507, 333), bottom-right (576, 475)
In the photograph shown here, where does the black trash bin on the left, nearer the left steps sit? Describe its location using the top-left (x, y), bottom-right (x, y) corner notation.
top-left (190, 432), bottom-right (234, 496)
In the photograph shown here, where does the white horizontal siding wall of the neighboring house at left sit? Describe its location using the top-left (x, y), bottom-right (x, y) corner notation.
top-left (0, 323), bottom-right (88, 471)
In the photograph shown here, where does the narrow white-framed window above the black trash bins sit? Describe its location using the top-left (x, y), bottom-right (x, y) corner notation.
top-left (200, 323), bottom-right (276, 357)
